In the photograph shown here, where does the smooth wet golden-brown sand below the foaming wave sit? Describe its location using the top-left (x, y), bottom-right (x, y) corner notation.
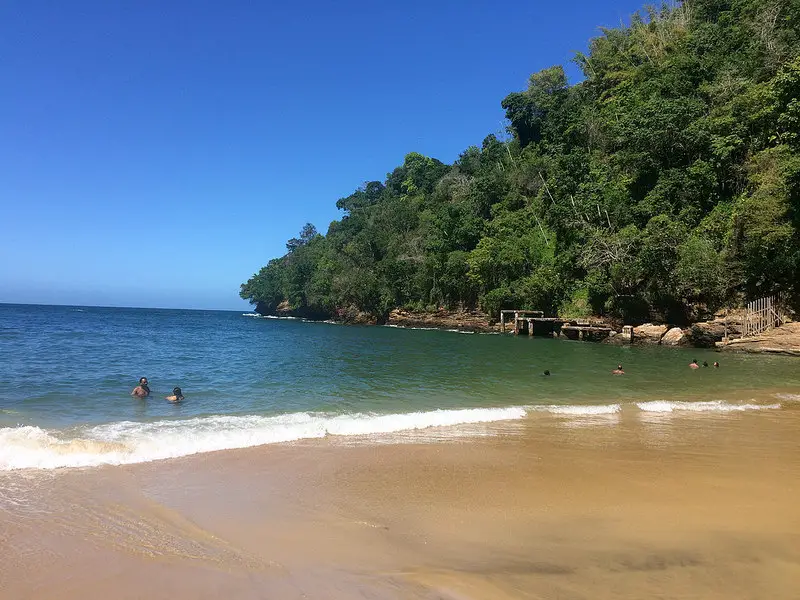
top-left (0, 401), bottom-right (800, 600)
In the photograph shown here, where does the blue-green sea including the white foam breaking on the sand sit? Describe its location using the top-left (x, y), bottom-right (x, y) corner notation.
top-left (0, 305), bottom-right (800, 469)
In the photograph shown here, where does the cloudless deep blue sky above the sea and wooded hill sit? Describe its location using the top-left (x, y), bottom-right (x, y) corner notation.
top-left (0, 0), bottom-right (641, 309)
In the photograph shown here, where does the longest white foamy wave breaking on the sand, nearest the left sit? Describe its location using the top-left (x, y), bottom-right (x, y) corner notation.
top-left (0, 406), bottom-right (527, 471)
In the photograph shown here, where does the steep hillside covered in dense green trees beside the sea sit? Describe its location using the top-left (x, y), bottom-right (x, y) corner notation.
top-left (241, 0), bottom-right (800, 322)
